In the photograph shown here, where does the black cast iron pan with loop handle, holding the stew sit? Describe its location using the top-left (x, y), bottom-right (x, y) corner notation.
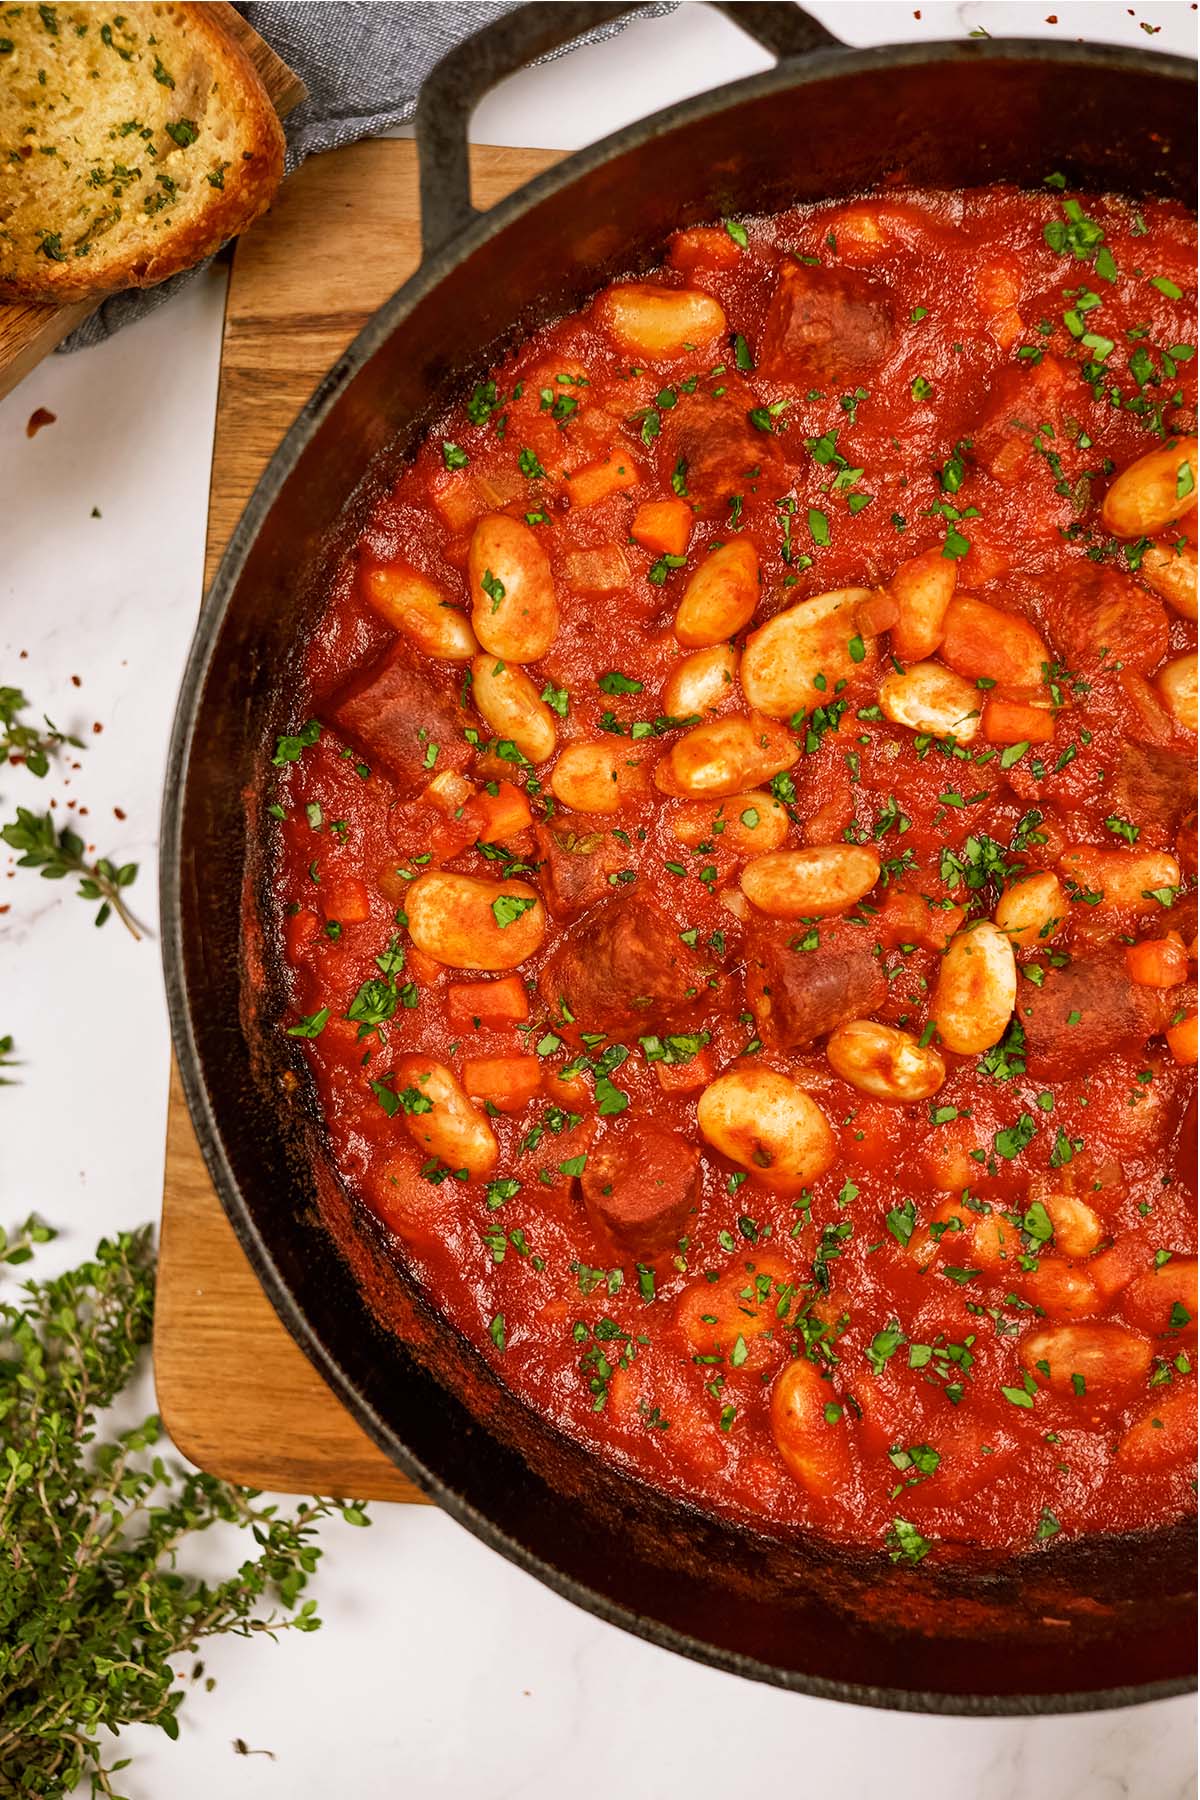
top-left (162, 4), bottom-right (1195, 1714)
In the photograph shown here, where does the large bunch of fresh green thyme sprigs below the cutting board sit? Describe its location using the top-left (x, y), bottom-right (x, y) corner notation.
top-left (0, 1220), bottom-right (369, 1800)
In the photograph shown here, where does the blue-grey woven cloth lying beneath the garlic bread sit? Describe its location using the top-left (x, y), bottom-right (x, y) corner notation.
top-left (58, 0), bottom-right (675, 351)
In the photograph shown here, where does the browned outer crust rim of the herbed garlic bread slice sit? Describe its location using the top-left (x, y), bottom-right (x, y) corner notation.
top-left (0, 0), bottom-right (284, 304)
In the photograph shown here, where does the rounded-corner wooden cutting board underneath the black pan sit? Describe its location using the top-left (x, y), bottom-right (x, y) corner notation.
top-left (155, 140), bottom-right (560, 1499)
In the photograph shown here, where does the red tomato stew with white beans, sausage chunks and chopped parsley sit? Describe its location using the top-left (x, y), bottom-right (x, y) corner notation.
top-left (272, 178), bottom-right (1196, 1561)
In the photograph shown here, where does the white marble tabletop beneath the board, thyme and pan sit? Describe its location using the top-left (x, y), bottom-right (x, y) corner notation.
top-left (0, 0), bottom-right (1196, 1800)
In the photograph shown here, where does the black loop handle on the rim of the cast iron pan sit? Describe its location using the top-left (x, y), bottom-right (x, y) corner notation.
top-left (414, 0), bottom-right (842, 257)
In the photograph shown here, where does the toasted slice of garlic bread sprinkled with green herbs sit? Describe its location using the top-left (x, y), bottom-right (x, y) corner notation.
top-left (0, 0), bottom-right (284, 304)
